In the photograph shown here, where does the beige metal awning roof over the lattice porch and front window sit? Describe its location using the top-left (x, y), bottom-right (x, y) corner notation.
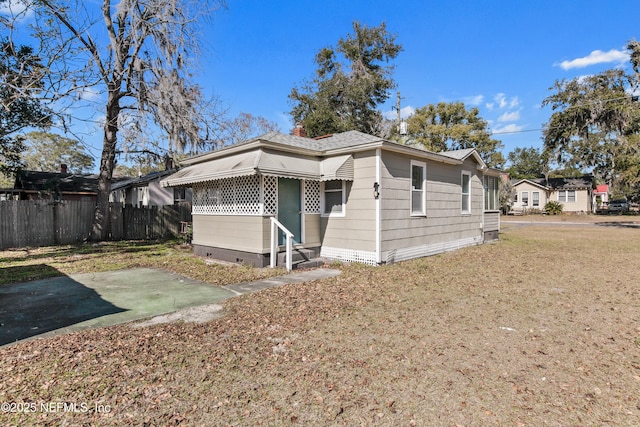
top-left (160, 148), bottom-right (353, 187)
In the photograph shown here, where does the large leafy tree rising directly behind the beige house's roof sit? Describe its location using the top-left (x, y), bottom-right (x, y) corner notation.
top-left (289, 21), bottom-right (402, 137)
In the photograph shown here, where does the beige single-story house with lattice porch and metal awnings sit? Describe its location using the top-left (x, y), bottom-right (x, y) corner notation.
top-left (160, 128), bottom-right (500, 266)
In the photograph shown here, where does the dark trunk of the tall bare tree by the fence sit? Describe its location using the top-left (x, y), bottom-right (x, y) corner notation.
top-left (91, 91), bottom-right (120, 241)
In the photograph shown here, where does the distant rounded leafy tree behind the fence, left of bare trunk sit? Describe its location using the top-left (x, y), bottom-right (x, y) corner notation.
top-left (23, 132), bottom-right (93, 174)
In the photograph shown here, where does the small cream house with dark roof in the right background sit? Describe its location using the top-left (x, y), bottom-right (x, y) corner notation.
top-left (511, 175), bottom-right (595, 214)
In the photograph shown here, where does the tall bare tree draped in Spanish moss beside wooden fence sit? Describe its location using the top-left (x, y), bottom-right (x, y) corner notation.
top-left (5, 0), bottom-right (225, 240)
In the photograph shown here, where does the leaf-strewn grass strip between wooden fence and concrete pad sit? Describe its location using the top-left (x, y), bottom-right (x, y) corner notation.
top-left (0, 241), bottom-right (283, 286)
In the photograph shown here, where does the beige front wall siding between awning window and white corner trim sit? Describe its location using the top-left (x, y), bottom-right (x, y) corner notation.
top-left (318, 150), bottom-right (376, 253)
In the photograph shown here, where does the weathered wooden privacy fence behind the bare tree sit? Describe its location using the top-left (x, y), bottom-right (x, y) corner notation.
top-left (0, 200), bottom-right (191, 249)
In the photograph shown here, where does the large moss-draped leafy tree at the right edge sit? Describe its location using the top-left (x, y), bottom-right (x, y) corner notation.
top-left (543, 69), bottom-right (640, 196)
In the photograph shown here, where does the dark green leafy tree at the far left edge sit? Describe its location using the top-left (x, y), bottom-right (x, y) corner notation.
top-left (0, 39), bottom-right (50, 180)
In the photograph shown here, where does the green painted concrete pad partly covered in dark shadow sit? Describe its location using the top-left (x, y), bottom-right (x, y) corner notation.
top-left (0, 268), bottom-right (237, 345)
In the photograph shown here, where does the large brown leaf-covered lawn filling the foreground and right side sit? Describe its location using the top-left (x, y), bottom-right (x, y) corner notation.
top-left (0, 225), bottom-right (640, 426)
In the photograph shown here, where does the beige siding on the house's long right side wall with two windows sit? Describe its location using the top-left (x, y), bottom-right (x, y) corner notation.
top-left (380, 152), bottom-right (484, 261)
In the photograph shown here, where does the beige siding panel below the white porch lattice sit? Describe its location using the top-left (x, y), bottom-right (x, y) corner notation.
top-left (193, 214), bottom-right (271, 253)
